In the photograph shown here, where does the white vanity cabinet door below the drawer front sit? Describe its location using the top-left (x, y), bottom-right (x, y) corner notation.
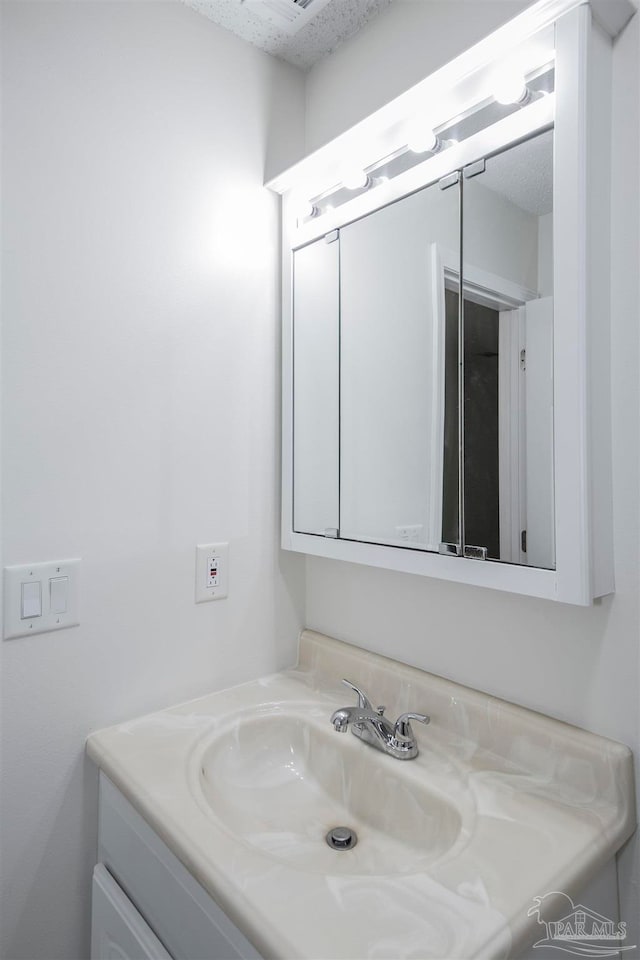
top-left (91, 863), bottom-right (171, 960)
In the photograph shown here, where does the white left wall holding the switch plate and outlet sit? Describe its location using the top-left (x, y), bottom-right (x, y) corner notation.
top-left (0, 2), bottom-right (303, 960)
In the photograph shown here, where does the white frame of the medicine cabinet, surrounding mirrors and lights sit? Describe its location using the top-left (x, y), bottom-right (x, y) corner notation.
top-left (269, 0), bottom-right (614, 605)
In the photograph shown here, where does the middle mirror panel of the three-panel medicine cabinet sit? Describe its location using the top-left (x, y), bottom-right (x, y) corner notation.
top-left (340, 184), bottom-right (460, 552)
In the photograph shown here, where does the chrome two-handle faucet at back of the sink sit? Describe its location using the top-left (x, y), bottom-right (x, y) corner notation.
top-left (331, 679), bottom-right (430, 760)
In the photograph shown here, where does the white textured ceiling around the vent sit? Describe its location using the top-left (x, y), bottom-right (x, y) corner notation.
top-left (184, 0), bottom-right (392, 70)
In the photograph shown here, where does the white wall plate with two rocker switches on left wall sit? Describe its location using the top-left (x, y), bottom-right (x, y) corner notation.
top-left (4, 559), bottom-right (80, 640)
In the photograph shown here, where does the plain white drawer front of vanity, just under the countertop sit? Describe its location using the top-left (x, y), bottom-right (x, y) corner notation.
top-left (98, 773), bottom-right (261, 960)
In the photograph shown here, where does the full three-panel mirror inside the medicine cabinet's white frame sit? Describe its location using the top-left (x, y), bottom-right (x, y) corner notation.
top-left (293, 130), bottom-right (555, 569)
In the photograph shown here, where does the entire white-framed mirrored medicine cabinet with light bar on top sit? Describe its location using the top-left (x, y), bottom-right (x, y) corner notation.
top-left (272, 0), bottom-right (613, 604)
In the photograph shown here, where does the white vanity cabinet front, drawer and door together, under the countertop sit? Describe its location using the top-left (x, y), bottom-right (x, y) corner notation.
top-left (91, 773), bottom-right (260, 960)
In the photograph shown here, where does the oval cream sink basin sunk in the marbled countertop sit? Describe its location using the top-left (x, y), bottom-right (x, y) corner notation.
top-left (192, 708), bottom-right (462, 875)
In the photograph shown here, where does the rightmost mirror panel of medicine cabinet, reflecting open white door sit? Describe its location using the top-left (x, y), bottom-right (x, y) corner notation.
top-left (458, 131), bottom-right (555, 568)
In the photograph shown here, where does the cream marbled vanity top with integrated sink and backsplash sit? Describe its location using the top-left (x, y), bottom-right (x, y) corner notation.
top-left (89, 631), bottom-right (635, 960)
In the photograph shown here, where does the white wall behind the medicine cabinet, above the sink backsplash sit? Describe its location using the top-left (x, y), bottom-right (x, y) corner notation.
top-left (306, 2), bottom-right (640, 944)
